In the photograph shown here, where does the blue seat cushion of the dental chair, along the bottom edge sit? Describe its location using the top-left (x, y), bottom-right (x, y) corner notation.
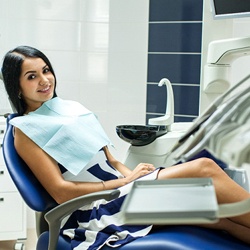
top-left (37, 226), bottom-right (250, 250)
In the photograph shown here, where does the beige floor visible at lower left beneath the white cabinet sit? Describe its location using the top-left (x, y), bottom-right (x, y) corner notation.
top-left (0, 229), bottom-right (37, 250)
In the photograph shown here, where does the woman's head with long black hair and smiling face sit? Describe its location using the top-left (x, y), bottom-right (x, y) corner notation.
top-left (2, 46), bottom-right (57, 115)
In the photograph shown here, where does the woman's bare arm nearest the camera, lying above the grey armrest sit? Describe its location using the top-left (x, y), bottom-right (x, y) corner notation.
top-left (14, 128), bottom-right (127, 204)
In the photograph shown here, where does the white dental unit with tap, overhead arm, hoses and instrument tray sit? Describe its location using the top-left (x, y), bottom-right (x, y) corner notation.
top-left (118, 37), bottom-right (250, 227)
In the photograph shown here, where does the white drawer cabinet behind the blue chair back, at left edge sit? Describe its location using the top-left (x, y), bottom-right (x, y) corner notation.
top-left (0, 116), bottom-right (27, 249)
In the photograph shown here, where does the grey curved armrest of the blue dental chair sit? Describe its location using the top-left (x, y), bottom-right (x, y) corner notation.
top-left (45, 190), bottom-right (120, 250)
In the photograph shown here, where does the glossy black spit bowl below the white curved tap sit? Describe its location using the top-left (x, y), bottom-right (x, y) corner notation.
top-left (116, 125), bottom-right (168, 146)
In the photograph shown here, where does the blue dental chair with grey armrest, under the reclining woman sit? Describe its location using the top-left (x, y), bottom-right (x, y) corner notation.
top-left (3, 114), bottom-right (250, 250)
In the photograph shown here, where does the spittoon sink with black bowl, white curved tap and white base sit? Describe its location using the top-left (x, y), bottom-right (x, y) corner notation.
top-left (116, 78), bottom-right (192, 168)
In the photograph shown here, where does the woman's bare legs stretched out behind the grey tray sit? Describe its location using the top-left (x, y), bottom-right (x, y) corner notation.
top-left (158, 158), bottom-right (250, 228)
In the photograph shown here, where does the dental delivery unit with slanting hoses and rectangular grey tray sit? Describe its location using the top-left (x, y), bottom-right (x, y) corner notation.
top-left (119, 76), bottom-right (250, 231)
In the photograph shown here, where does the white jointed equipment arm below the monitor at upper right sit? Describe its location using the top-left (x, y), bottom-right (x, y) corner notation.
top-left (203, 37), bottom-right (250, 93)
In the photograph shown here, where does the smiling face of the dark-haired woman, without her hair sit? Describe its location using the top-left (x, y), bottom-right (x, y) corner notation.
top-left (20, 58), bottom-right (55, 113)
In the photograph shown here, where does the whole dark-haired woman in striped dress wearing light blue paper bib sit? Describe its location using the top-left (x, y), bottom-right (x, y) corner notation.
top-left (2, 46), bottom-right (250, 250)
